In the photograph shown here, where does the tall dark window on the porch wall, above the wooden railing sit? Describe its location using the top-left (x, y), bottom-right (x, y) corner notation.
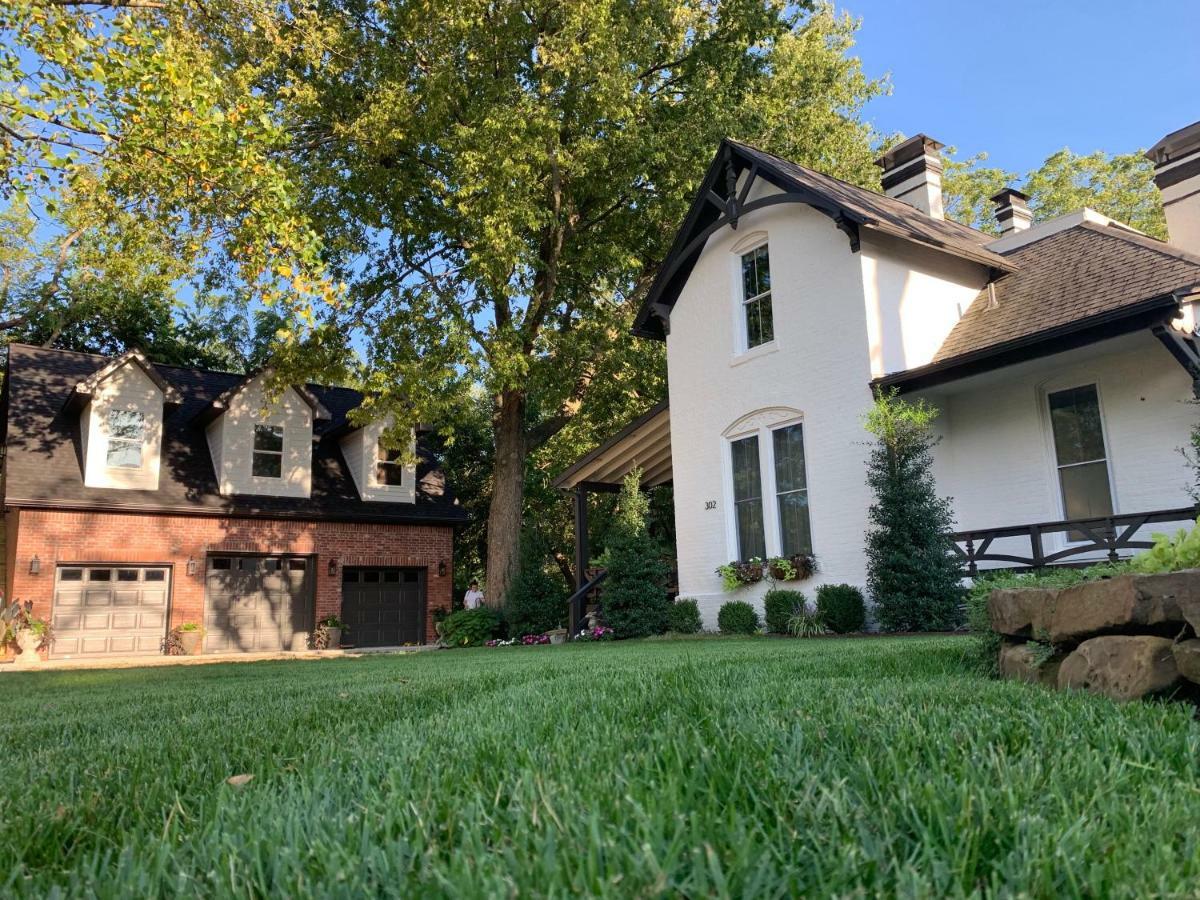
top-left (1048, 384), bottom-right (1112, 540)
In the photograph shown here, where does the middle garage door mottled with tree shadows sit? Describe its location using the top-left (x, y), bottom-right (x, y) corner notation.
top-left (204, 556), bottom-right (313, 653)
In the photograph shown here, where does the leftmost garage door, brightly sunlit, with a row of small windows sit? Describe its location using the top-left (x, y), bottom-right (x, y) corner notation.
top-left (50, 565), bottom-right (170, 658)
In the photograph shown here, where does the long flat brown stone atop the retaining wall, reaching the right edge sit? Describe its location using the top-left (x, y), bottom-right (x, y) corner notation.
top-left (1049, 570), bottom-right (1200, 643)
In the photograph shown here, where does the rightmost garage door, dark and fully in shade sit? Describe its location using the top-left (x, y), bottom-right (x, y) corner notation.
top-left (342, 566), bottom-right (425, 647)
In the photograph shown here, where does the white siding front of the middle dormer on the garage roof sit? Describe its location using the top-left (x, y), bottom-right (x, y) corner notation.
top-left (208, 378), bottom-right (312, 497)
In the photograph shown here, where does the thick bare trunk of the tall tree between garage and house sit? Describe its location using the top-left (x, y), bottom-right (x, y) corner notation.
top-left (486, 390), bottom-right (527, 607)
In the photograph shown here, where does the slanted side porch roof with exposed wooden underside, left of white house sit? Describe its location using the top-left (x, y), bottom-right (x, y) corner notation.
top-left (554, 401), bottom-right (672, 491)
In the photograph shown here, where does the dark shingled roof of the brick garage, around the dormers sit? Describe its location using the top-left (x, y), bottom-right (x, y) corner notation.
top-left (4, 344), bottom-right (467, 524)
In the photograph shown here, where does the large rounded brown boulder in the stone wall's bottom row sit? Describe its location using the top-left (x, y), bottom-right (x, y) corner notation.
top-left (1058, 635), bottom-right (1180, 701)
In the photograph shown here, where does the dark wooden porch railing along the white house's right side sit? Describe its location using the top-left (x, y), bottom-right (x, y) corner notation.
top-left (953, 506), bottom-right (1196, 577)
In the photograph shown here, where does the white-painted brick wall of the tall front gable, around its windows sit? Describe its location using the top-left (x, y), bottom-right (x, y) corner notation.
top-left (667, 188), bottom-right (871, 628)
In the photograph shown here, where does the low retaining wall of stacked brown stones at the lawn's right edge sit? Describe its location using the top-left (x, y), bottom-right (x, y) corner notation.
top-left (988, 569), bottom-right (1200, 700)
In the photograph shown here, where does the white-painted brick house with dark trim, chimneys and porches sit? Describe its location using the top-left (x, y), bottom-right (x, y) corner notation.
top-left (558, 122), bottom-right (1200, 626)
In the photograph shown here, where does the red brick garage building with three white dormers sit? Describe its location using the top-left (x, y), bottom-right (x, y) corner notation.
top-left (4, 346), bottom-right (464, 658)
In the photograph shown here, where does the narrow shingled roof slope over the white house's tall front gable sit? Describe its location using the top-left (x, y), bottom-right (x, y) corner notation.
top-left (730, 140), bottom-right (1016, 271)
